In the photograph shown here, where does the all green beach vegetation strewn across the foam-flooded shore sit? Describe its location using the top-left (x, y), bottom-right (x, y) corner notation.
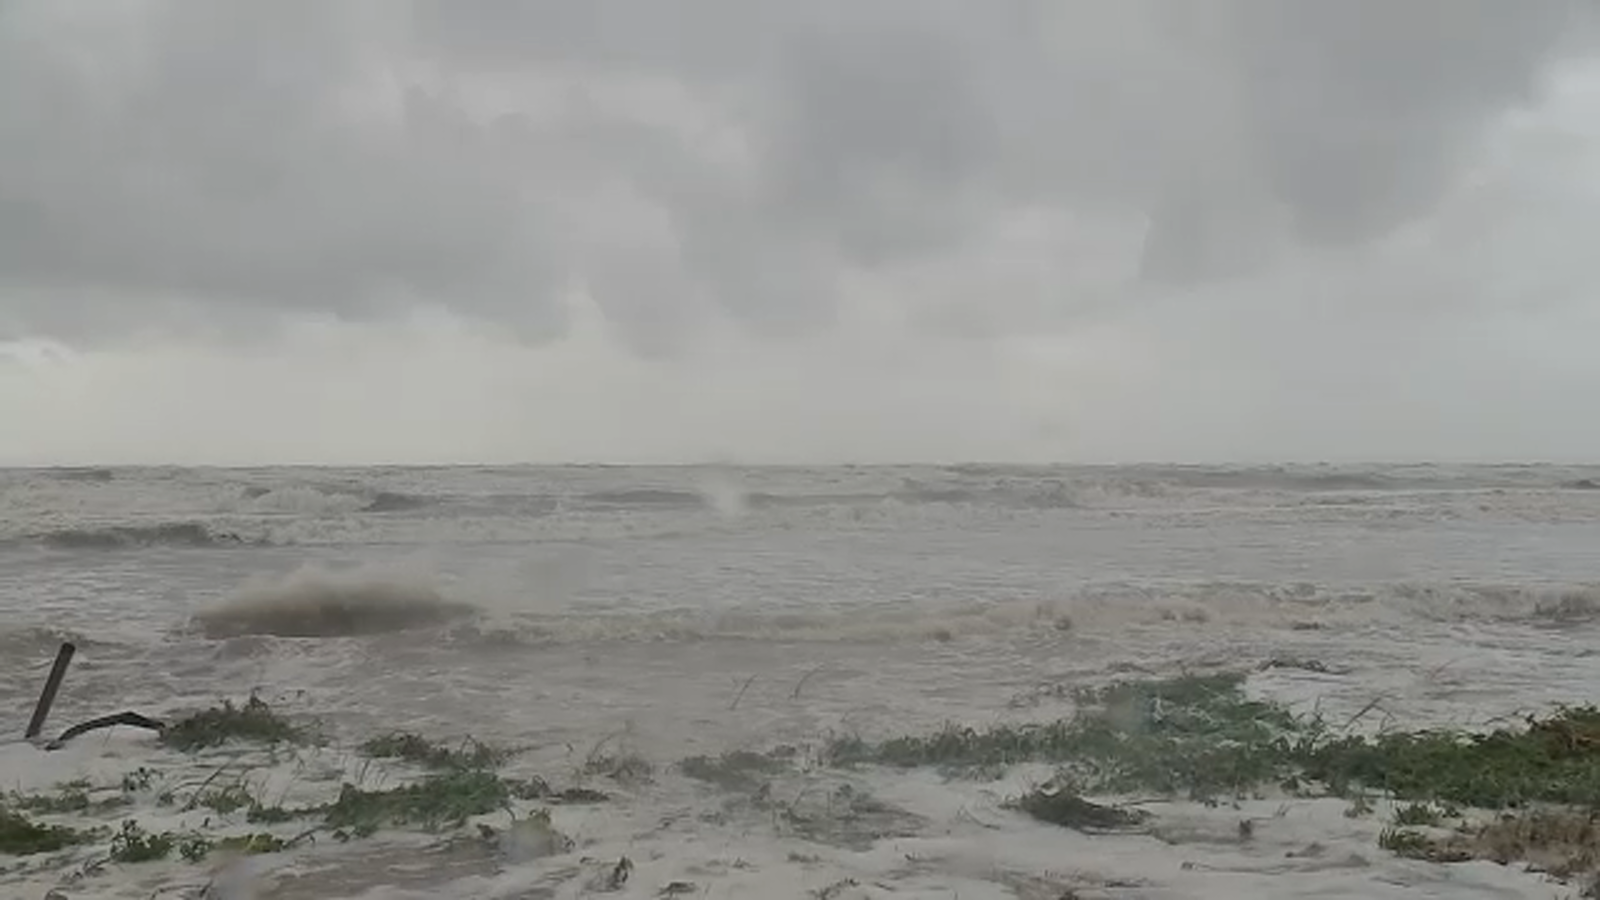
top-left (9, 673), bottom-right (1600, 890)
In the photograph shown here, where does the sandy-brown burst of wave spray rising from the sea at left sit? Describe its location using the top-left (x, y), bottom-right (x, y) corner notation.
top-left (190, 569), bottom-right (478, 639)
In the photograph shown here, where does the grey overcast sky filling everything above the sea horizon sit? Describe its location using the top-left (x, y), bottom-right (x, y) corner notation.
top-left (0, 0), bottom-right (1600, 463)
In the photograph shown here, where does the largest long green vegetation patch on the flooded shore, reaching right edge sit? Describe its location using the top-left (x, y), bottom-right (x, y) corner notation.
top-left (827, 674), bottom-right (1600, 809)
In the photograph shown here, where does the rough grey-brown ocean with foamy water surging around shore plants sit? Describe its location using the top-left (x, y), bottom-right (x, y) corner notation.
top-left (0, 464), bottom-right (1600, 900)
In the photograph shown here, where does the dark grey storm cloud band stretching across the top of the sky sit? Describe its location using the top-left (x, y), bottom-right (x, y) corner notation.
top-left (0, 0), bottom-right (1587, 342)
